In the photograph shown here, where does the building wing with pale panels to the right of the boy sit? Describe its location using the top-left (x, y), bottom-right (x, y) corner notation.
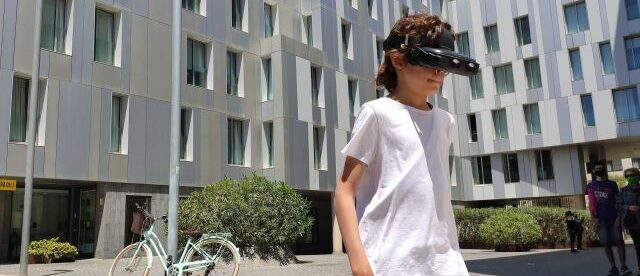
top-left (443, 0), bottom-right (640, 207)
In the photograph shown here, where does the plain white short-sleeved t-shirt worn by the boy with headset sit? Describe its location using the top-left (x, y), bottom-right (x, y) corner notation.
top-left (342, 97), bottom-right (469, 276)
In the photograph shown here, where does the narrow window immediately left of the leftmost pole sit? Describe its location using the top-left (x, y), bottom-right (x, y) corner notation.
top-left (9, 77), bottom-right (29, 142)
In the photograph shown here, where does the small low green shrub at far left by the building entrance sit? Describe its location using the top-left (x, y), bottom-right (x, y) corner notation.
top-left (29, 237), bottom-right (78, 263)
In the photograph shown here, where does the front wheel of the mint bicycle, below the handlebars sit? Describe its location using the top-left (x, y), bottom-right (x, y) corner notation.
top-left (109, 243), bottom-right (153, 276)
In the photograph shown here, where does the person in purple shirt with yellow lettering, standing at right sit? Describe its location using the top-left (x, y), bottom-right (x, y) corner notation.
top-left (587, 162), bottom-right (631, 275)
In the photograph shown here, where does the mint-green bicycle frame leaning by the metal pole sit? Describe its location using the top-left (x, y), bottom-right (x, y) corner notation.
top-left (130, 225), bottom-right (230, 275)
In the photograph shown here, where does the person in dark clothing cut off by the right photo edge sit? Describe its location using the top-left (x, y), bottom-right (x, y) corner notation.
top-left (616, 168), bottom-right (640, 274)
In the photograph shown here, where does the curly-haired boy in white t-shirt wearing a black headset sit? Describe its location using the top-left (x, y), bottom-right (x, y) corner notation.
top-left (334, 14), bottom-right (470, 276)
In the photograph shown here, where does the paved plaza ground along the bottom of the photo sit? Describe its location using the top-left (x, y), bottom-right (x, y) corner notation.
top-left (0, 245), bottom-right (638, 276)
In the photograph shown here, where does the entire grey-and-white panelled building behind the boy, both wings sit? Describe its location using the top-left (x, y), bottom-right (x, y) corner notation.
top-left (0, 0), bottom-right (640, 262)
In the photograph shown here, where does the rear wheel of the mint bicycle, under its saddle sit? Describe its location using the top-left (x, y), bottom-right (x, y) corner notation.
top-left (184, 238), bottom-right (240, 276)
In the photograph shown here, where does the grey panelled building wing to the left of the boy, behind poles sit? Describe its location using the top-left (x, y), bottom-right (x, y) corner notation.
top-left (0, 0), bottom-right (450, 262)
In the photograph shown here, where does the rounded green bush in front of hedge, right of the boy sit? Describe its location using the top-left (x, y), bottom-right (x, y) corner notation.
top-left (479, 210), bottom-right (542, 250)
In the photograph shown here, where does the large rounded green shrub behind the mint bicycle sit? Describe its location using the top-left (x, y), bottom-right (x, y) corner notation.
top-left (179, 173), bottom-right (313, 263)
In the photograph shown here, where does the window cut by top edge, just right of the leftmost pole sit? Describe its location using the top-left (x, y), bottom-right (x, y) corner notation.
top-left (40, 0), bottom-right (67, 53)
